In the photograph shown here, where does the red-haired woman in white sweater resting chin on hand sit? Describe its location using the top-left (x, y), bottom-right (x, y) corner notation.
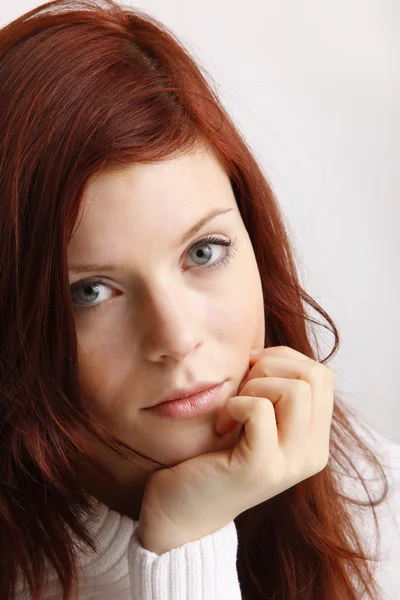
top-left (0, 0), bottom-right (400, 600)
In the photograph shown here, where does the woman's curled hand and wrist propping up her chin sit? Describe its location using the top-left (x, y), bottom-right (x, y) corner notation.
top-left (138, 346), bottom-right (334, 554)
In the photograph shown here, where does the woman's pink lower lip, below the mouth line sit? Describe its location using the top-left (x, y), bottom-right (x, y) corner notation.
top-left (144, 381), bottom-right (225, 419)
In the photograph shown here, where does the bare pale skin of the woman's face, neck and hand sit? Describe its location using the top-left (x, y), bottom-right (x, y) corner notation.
top-left (68, 142), bottom-right (334, 554)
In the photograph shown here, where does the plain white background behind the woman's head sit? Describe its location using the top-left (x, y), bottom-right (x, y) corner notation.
top-left (0, 0), bottom-right (400, 443)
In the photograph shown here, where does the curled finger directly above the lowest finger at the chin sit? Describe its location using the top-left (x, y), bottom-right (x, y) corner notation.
top-left (236, 377), bottom-right (312, 454)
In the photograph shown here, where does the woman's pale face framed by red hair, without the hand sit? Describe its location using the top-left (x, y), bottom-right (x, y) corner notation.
top-left (68, 144), bottom-right (264, 466)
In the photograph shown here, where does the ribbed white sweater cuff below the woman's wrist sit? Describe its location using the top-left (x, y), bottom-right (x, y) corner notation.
top-left (128, 521), bottom-right (242, 600)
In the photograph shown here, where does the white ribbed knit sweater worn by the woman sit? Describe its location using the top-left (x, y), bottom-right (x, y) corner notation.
top-left (26, 414), bottom-right (400, 600)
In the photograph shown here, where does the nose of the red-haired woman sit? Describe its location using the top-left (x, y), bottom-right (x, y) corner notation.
top-left (142, 282), bottom-right (204, 362)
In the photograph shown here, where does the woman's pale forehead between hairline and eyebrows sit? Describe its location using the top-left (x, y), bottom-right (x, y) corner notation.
top-left (68, 149), bottom-right (236, 260)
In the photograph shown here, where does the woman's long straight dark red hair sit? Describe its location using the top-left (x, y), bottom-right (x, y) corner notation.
top-left (0, 0), bottom-right (388, 600)
